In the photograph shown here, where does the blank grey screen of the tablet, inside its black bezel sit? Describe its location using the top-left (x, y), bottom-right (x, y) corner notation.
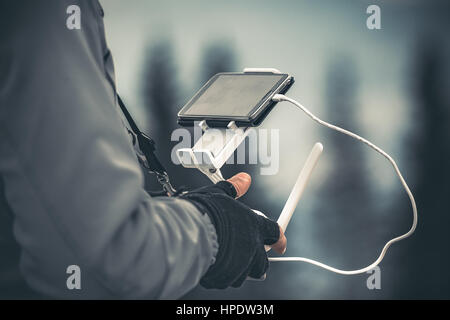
top-left (184, 74), bottom-right (286, 117)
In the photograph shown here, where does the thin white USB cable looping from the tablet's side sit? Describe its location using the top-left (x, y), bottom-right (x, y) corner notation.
top-left (269, 94), bottom-right (417, 275)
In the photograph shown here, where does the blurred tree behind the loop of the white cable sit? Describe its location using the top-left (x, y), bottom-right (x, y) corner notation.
top-left (308, 56), bottom-right (377, 298)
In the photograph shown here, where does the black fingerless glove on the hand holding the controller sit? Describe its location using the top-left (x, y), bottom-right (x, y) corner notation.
top-left (182, 181), bottom-right (280, 289)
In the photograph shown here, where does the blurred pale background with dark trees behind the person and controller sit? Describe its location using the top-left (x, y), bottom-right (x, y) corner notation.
top-left (101, 0), bottom-right (450, 299)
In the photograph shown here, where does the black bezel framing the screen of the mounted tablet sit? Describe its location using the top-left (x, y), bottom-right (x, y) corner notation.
top-left (178, 72), bottom-right (293, 127)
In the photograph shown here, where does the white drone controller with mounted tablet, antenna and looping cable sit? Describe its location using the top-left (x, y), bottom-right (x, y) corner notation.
top-left (176, 68), bottom-right (417, 280)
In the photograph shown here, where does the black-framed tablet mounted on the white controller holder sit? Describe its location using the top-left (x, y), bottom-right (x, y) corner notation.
top-left (178, 72), bottom-right (294, 127)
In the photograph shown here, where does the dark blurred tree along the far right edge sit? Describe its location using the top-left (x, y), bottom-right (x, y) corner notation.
top-left (396, 37), bottom-right (450, 299)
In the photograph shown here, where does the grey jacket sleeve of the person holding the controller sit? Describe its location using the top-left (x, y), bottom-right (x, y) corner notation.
top-left (0, 1), bottom-right (217, 298)
